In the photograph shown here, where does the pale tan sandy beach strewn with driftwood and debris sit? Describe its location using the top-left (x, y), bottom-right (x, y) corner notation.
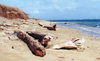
top-left (0, 17), bottom-right (100, 61)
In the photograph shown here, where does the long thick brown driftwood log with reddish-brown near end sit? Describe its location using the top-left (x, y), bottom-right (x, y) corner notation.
top-left (17, 31), bottom-right (46, 57)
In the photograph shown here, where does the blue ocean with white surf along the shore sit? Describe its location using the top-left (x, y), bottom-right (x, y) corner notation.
top-left (48, 19), bottom-right (100, 38)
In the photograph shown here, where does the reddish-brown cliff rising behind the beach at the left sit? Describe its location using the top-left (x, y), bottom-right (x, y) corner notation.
top-left (0, 4), bottom-right (29, 20)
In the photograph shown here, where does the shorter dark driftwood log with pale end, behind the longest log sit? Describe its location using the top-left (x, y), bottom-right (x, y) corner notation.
top-left (27, 31), bottom-right (52, 47)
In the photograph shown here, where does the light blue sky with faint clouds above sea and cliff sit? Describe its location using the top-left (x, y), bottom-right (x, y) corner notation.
top-left (0, 0), bottom-right (100, 20)
